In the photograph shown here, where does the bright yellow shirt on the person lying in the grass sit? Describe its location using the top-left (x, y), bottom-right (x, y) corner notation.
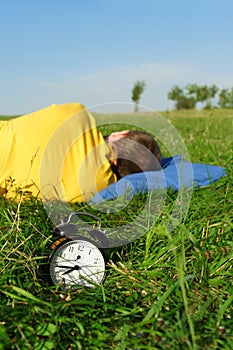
top-left (0, 103), bottom-right (116, 202)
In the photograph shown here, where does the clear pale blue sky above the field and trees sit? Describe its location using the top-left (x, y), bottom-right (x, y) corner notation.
top-left (0, 0), bottom-right (233, 115)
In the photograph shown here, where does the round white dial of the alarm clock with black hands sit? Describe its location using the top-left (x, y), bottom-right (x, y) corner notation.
top-left (49, 239), bottom-right (105, 288)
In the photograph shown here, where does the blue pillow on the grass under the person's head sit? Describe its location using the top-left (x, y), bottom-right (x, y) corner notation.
top-left (91, 155), bottom-right (226, 203)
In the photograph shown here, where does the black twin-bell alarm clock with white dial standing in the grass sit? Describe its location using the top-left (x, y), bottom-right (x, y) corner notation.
top-left (48, 212), bottom-right (108, 289)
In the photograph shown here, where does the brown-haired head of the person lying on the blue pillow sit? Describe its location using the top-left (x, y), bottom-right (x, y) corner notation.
top-left (113, 130), bottom-right (161, 178)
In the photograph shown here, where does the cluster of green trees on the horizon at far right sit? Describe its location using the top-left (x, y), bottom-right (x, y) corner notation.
top-left (167, 84), bottom-right (233, 109)
